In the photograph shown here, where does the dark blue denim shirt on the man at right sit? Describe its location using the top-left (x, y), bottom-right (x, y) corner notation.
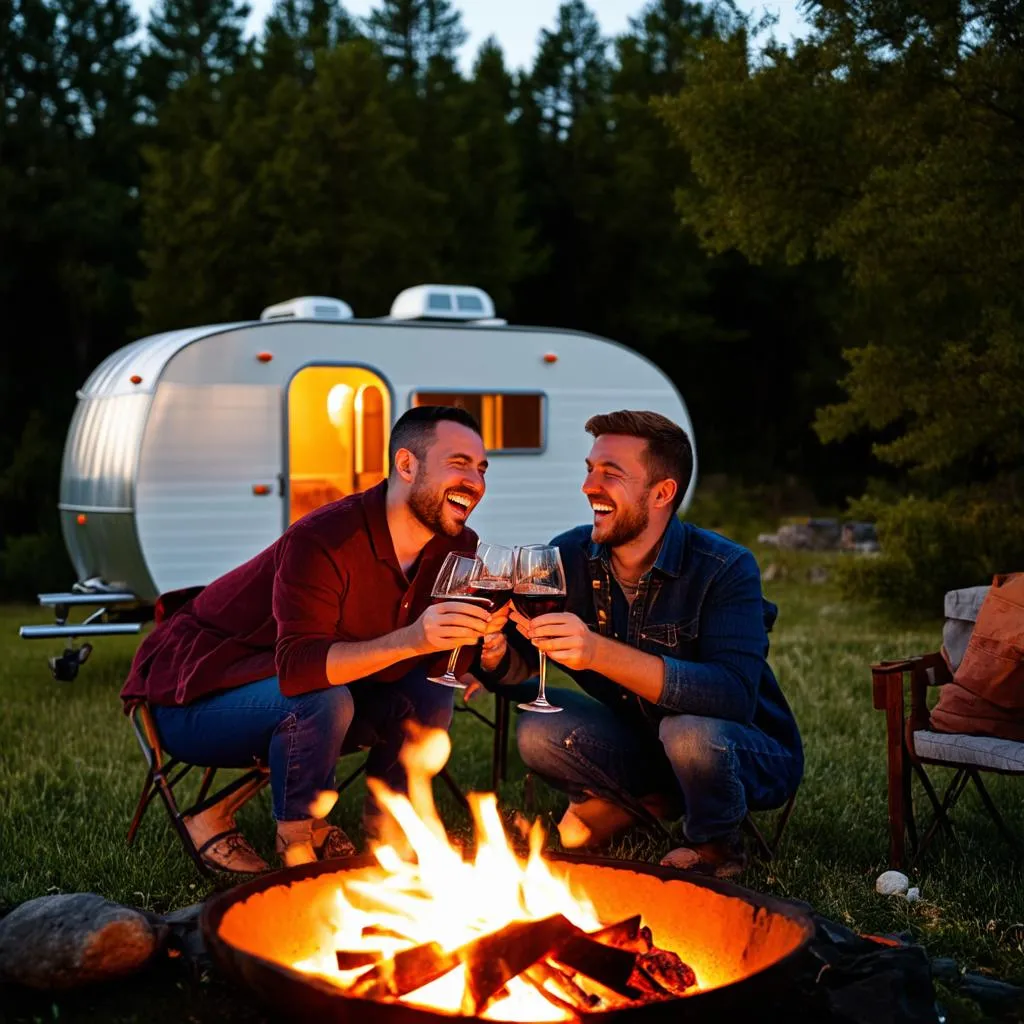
top-left (516, 517), bottom-right (803, 763)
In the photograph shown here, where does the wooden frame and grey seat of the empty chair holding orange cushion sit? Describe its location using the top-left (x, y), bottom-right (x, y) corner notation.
top-left (871, 653), bottom-right (1024, 867)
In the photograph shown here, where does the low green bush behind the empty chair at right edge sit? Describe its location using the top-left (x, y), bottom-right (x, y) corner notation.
top-left (840, 492), bottom-right (1024, 614)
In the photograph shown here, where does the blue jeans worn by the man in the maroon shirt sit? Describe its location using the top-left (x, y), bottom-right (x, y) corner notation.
top-left (153, 669), bottom-right (455, 830)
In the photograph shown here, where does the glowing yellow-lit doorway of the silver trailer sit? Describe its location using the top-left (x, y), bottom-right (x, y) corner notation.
top-left (286, 366), bottom-right (391, 523)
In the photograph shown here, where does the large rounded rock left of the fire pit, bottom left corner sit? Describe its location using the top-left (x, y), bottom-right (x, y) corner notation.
top-left (0, 893), bottom-right (165, 989)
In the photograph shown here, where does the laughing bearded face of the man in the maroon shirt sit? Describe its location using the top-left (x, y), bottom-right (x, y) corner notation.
top-left (409, 420), bottom-right (487, 537)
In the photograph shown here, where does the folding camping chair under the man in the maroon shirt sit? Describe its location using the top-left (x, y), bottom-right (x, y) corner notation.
top-left (126, 700), bottom-right (469, 876)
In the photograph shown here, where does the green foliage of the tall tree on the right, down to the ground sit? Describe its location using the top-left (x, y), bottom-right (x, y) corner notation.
top-left (660, 0), bottom-right (1024, 604)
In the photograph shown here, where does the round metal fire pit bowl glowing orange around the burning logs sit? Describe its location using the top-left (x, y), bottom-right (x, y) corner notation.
top-left (202, 855), bottom-right (814, 1024)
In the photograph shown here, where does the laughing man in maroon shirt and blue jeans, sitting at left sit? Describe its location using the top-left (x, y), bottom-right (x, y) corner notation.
top-left (121, 406), bottom-right (508, 871)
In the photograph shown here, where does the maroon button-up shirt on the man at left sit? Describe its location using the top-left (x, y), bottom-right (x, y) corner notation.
top-left (121, 480), bottom-right (477, 706)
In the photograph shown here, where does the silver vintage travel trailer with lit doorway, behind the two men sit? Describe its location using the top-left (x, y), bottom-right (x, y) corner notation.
top-left (22, 285), bottom-right (693, 673)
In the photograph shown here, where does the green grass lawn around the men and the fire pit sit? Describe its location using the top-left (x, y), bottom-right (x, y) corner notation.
top-left (0, 552), bottom-right (1024, 1021)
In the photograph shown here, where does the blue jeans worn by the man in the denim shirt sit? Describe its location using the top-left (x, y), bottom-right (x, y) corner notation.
top-left (516, 689), bottom-right (801, 843)
